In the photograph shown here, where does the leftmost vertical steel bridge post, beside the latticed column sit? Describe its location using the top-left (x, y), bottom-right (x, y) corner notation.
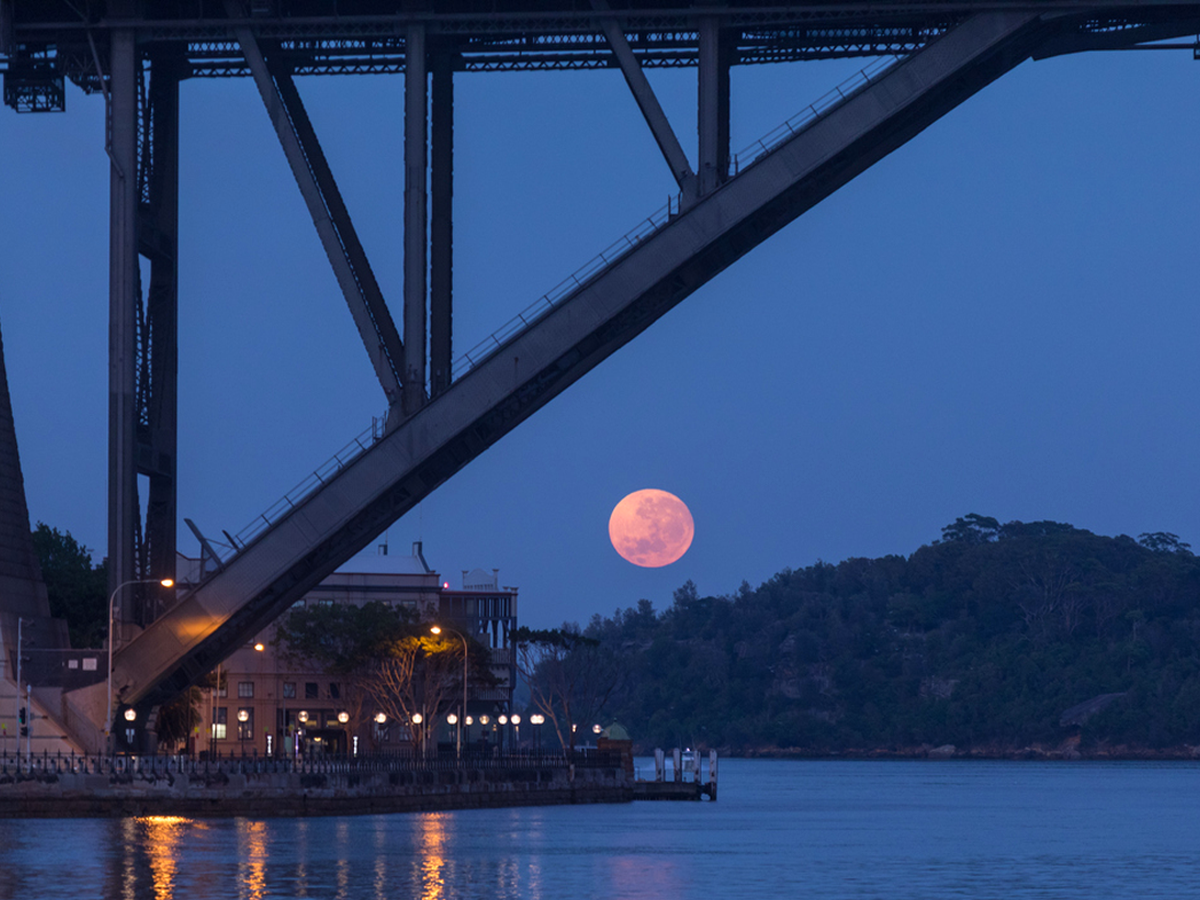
top-left (107, 22), bottom-right (142, 638)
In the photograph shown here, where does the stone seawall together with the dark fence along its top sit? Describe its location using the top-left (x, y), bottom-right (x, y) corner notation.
top-left (0, 750), bottom-right (634, 818)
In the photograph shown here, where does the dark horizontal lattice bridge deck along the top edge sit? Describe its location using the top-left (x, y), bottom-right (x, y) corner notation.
top-left (7, 0), bottom-right (1200, 101)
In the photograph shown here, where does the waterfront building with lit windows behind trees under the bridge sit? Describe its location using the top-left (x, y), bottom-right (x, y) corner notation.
top-left (178, 542), bottom-right (517, 756)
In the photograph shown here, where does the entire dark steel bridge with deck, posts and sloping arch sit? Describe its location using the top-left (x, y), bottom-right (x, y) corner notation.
top-left (0, 0), bottom-right (1200, 750)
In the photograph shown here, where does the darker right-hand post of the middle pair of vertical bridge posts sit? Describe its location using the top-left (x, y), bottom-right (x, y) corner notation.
top-left (430, 49), bottom-right (454, 397)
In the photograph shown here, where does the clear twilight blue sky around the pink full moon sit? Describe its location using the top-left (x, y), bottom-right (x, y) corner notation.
top-left (0, 52), bottom-right (1200, 625)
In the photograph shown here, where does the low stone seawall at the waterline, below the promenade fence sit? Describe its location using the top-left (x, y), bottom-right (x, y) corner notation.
top-left (0, 766), bottom-right (634, 818)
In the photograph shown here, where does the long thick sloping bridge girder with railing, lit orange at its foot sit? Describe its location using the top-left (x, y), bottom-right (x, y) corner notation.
top-left (75, 11), bottom-right (1052, 734)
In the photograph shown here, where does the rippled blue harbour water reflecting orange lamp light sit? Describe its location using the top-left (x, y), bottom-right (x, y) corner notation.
top-left (0, 760), bottom-right (1200, 900)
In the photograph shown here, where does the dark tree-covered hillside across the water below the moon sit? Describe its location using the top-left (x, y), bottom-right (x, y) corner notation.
top-left (586, 515), bottom-right (1200, 754)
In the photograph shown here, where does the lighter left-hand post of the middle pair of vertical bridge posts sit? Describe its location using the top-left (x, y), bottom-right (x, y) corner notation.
top-left (403, 24), bottom-right (430, 415)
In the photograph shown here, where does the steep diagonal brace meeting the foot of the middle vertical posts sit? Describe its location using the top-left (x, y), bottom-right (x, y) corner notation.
top-left (230, 4), bottom-right (404, 407)
